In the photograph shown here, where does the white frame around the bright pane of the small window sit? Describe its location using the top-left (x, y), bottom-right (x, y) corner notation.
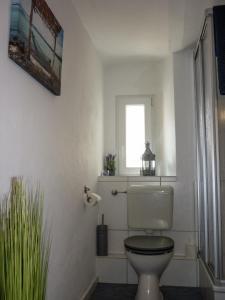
top-left (116, 95), bottom-right (152, 175)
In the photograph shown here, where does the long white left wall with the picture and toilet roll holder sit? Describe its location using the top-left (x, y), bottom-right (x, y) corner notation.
top-left (0, 0), bottom-right (103, 300)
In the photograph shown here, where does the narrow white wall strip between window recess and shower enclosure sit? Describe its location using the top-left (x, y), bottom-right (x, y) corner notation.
top-left (173, 48), bottom-right (197, 276)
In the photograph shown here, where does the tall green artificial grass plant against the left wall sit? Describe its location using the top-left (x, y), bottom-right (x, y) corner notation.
top-left (0, 178), bottom-right (50, 300)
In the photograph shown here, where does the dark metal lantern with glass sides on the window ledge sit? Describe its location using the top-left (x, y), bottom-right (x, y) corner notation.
top-left (141, 142), bottom-right (155, 176)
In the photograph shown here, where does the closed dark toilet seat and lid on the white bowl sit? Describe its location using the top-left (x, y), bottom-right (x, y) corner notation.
top-left (124, 236), bottom-right (174, 255)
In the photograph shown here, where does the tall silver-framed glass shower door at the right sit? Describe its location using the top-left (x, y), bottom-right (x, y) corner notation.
top-left (195, 11), bottom-right (225, 279)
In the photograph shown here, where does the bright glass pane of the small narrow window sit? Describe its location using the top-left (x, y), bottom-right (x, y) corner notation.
top-left (125, 105), bottom-right (145, 168)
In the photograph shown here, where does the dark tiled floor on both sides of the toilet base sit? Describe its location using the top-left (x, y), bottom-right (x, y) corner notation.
top-left (91, 283), bottom-right (202, 300)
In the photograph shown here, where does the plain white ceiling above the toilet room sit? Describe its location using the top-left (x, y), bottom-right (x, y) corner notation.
top-left (72, 0), bottom-right (213, 60)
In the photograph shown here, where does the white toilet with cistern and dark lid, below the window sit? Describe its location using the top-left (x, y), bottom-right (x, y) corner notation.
top-left (124, 185), bottom-right (174, 300)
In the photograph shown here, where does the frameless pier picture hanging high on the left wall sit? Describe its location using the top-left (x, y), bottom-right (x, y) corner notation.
top-left (8, 0), bottom-right (63, 95)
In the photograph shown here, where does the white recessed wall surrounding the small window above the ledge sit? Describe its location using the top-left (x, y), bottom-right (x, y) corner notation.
top-left (104, 59), bottom-right (176, 175)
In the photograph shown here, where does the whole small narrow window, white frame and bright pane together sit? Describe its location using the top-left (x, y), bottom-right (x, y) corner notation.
top-left (116, 96), bottom-right (151, 175)
